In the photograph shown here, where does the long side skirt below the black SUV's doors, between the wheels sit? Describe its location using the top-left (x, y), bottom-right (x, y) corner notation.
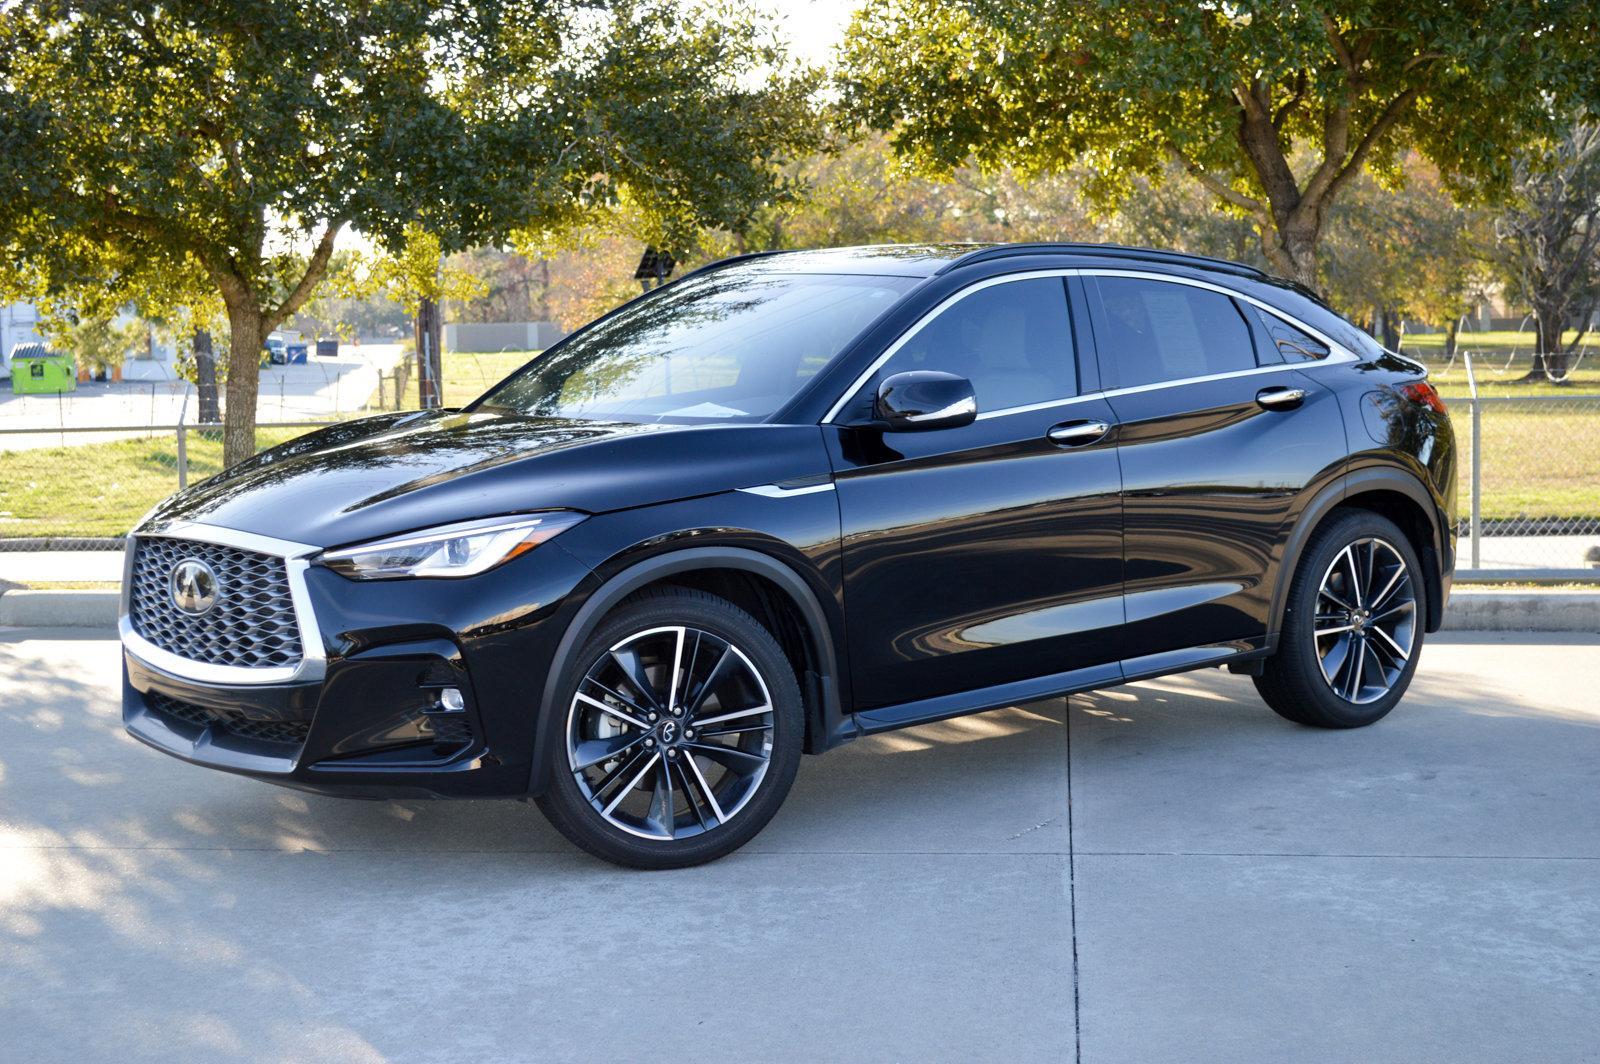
top-left (853, 635), bottom-right (1272, 734)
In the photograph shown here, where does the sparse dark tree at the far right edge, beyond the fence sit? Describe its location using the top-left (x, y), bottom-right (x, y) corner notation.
top-left (1493, 123), bottom-right (1600, 384)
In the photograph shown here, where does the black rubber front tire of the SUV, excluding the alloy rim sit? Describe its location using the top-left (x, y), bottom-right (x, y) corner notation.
top-left (539, 589), bottom-right (805, 869)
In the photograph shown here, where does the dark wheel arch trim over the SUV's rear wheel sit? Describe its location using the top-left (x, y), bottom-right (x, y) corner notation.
top-left (1272, 466), bottom-right (1445, 640)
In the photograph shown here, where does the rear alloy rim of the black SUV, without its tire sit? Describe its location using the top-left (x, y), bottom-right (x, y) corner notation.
top-left (1312, 536), bottom-right (1416, 704)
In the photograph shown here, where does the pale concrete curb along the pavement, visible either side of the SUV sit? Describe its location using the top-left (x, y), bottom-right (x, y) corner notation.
top-left (0, 589), bottom-right (1600, 635)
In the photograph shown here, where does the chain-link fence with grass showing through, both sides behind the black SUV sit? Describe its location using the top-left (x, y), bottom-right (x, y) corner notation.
top-left (0, 350), bottom-right (1600, 579)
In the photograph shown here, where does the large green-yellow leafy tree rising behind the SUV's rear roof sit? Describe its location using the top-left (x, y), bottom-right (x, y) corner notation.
top-left (840, 0), bottom-right (1600, 286)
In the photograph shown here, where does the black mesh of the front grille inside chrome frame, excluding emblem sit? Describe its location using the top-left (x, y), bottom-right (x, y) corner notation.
top-left (128, 536), bottom-right (302, 669)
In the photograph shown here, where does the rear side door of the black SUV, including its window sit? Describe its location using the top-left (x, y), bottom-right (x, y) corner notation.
top-left (1085, 272), bottom-right (1346, 674)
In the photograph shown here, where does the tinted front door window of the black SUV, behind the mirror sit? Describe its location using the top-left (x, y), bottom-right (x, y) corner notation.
top-left (877, 277), bottom-right (1078, 411)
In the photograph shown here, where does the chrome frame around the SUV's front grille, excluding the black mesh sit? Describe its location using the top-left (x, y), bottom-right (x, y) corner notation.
top-left (117, 522), bottom-right (328, 686)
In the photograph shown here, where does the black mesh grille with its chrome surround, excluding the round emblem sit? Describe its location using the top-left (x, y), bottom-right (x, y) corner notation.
top-left (118, 522), bottom-right (326, 685)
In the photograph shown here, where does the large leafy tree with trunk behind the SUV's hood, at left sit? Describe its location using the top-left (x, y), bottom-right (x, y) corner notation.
top-left (0, 0), bottom-right (810, 464)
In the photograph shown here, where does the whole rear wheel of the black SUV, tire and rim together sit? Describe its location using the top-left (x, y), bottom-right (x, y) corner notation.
top-left (1256, 510), bottom-right (1424, 728)
